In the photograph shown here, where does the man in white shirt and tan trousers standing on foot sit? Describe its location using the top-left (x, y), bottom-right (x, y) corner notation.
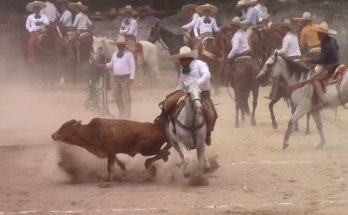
top-left (105, 36), bottom-right (135, 118)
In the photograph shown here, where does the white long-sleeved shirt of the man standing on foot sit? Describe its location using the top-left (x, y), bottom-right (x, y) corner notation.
top-left (106, 50), bottom-right (135, 80)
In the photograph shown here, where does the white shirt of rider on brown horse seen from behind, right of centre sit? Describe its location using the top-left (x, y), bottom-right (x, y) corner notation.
top-left (227, 29), bottom-right (250, 59)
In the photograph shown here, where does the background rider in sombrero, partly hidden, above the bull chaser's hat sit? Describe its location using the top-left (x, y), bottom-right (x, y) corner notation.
top-left (181, 4), bottom-right (200, 46)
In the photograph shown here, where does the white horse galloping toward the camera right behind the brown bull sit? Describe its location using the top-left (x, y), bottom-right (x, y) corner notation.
top-left (166, 80), bottom-right (208, 176)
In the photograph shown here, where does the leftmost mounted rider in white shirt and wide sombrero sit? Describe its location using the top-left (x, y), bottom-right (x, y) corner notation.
top-left (25, 1), bottom-right (50, 62)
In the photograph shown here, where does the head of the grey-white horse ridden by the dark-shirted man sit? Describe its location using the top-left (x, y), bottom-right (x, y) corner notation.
top-left (256, 50), bottom-right (282, 86)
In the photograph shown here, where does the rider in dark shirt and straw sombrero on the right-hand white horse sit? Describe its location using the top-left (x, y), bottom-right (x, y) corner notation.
top-left (304, 22), bottom-right (339, 109)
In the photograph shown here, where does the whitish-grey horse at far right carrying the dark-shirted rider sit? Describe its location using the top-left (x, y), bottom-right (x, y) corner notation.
top-left (257, 51), bottom-right (348, 149)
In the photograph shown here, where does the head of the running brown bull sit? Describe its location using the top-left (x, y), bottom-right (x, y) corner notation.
top-left (52, 119), bottom-right (81, 143)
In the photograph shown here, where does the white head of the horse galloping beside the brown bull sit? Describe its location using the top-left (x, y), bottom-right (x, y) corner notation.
top-left (185, 80), bottom-right (203, 113)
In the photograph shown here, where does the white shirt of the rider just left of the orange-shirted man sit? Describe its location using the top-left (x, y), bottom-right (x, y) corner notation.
top-left (278, 32), bottom-right (301, 57)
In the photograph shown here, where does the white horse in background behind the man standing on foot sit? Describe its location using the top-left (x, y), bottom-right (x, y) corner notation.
top-left (93, 37), bottom-right (159, 86)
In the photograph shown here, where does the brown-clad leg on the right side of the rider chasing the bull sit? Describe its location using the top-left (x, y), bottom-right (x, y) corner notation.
top-left (201, 91), bottom-right (218, 146)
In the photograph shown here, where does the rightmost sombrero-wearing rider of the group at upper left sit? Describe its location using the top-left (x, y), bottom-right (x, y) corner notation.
top-left (68, 2), bottom-right (92, 43)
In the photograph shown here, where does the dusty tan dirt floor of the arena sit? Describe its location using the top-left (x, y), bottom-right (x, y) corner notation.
top-left (0, 72), bottom-right (348, 215)
